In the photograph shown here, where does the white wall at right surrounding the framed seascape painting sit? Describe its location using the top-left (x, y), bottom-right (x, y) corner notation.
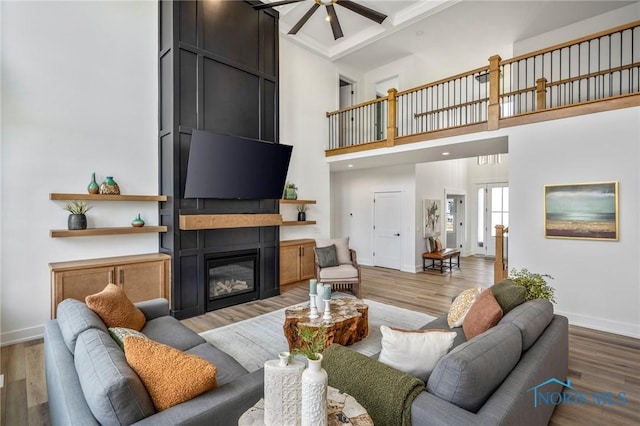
top-left (509, 108), bottom-right (640, 337)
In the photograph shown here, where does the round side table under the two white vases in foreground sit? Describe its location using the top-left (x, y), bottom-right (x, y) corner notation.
top-left (238, 386), bottom-right (373, 426)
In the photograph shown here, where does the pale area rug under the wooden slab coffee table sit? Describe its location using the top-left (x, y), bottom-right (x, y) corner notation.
top-left (200, 299), bottom-right (434, 371)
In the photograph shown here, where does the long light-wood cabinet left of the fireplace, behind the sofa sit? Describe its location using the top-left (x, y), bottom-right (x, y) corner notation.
top-left (49, 253), bottom-right (171, 318)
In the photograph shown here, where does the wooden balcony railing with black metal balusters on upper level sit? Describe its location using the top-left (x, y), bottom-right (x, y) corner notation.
top-left (326, 21), bottom-right (640, 155)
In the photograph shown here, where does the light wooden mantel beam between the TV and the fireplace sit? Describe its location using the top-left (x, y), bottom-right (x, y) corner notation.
top-left (180, 213), bottom-right (282, 231)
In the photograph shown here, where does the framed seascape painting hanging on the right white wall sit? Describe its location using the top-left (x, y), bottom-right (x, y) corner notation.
top-left (544, 182), bottom-right (618, 240)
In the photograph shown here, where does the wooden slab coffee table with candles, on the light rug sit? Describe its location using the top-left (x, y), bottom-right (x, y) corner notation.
top-left (282, 297), bottom-right (369, 351)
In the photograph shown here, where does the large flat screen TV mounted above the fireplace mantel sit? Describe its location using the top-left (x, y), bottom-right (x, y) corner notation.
top-left (184, 129), bottom-right (293, 200)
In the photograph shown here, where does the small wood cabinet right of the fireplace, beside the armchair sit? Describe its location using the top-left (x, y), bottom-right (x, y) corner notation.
top-left (280, 239), bottom-right (316, 285)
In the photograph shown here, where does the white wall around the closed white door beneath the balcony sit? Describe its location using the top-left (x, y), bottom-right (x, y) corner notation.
top-left (331, 165), bottom-right (416, 272)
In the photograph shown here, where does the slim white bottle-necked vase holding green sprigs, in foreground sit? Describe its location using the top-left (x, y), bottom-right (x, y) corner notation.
top-left (302, 354), bottom-right (328, 426)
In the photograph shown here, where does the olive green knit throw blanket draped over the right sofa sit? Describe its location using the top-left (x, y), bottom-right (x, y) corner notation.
top-left (322, 344), bottom-right (424, 426)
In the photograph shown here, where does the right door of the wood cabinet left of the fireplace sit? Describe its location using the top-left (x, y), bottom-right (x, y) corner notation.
top-left (116, 261), bottom-right (166, 303)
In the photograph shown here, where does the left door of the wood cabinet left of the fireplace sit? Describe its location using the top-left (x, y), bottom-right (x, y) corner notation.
top-left (51, 266), bottom-right (114, 318)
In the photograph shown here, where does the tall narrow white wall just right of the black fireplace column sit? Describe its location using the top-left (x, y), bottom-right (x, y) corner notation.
top-left (280, 36), bottom-right (338, 240)
